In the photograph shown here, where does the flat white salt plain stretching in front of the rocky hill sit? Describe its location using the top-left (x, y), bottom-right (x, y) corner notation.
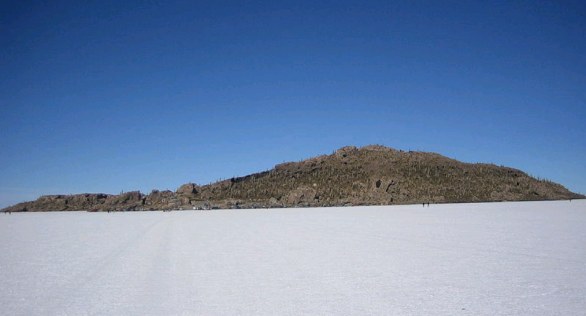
top-left (0, 200), bottom-right (586, 315)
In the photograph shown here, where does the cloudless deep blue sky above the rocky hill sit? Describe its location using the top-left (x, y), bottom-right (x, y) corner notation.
top-left (0, 0), bottom-right (586, 206)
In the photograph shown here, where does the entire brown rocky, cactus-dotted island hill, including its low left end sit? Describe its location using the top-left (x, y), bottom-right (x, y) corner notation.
top-left (3, 145), bottom-right (585, 212)
